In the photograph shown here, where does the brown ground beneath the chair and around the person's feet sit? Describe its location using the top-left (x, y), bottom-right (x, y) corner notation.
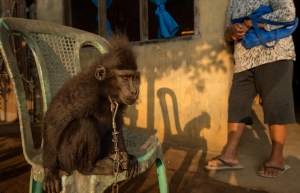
top-left (0, 91), bottom-right (300, 193)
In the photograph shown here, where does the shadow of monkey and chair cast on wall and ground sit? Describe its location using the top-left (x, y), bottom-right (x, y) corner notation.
top-left (157, 88), bottom-right (210, 192)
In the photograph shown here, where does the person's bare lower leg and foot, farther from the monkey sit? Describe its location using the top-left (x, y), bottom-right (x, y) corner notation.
top-left (259, 124), bottom-right (287, 176)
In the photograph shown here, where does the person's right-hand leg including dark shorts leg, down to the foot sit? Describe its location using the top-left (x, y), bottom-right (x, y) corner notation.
top-left (256, 61), bottom-right (295, 176)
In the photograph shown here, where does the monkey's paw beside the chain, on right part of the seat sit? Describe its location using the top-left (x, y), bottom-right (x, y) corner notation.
top-left (120, 152), bottom-right (140, 179)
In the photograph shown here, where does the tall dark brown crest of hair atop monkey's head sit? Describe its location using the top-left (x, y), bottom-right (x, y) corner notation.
top-left (102, 32), bottom-right (138, 70)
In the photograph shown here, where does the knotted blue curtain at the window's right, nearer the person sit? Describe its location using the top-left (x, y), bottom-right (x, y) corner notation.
top-left (151, 0), bottom-right (179, 39)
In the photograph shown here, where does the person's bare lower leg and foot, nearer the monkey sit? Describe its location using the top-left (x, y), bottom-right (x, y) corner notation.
top-left (207, 123), bottom-right (245, 167)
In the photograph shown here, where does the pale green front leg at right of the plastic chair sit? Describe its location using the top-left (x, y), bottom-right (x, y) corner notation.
top-left (155, 158), bottom-right (169, 193)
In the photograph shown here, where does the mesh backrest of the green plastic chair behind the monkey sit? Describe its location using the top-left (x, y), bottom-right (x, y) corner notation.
top-left (0, 17), bottom-right (108, 165)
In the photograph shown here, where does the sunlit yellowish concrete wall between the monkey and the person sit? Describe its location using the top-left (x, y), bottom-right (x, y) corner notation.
top-left (41, 0), bottom-right (233, 151)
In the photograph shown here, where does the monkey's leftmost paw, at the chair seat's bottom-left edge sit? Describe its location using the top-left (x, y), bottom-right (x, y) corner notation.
top-left (43, 168), bottom-right (69, 193)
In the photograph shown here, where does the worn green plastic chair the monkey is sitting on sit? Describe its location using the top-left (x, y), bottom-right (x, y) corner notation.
top-left (0, 17), bottom-right (168, 193)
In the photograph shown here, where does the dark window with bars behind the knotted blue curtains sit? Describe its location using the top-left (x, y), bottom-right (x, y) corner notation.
top-left (65, 0), bottom-right (199, 41)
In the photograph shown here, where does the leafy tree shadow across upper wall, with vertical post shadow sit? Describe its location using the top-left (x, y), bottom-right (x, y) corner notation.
top-left (137, 38), bottom-right (231, 133)
